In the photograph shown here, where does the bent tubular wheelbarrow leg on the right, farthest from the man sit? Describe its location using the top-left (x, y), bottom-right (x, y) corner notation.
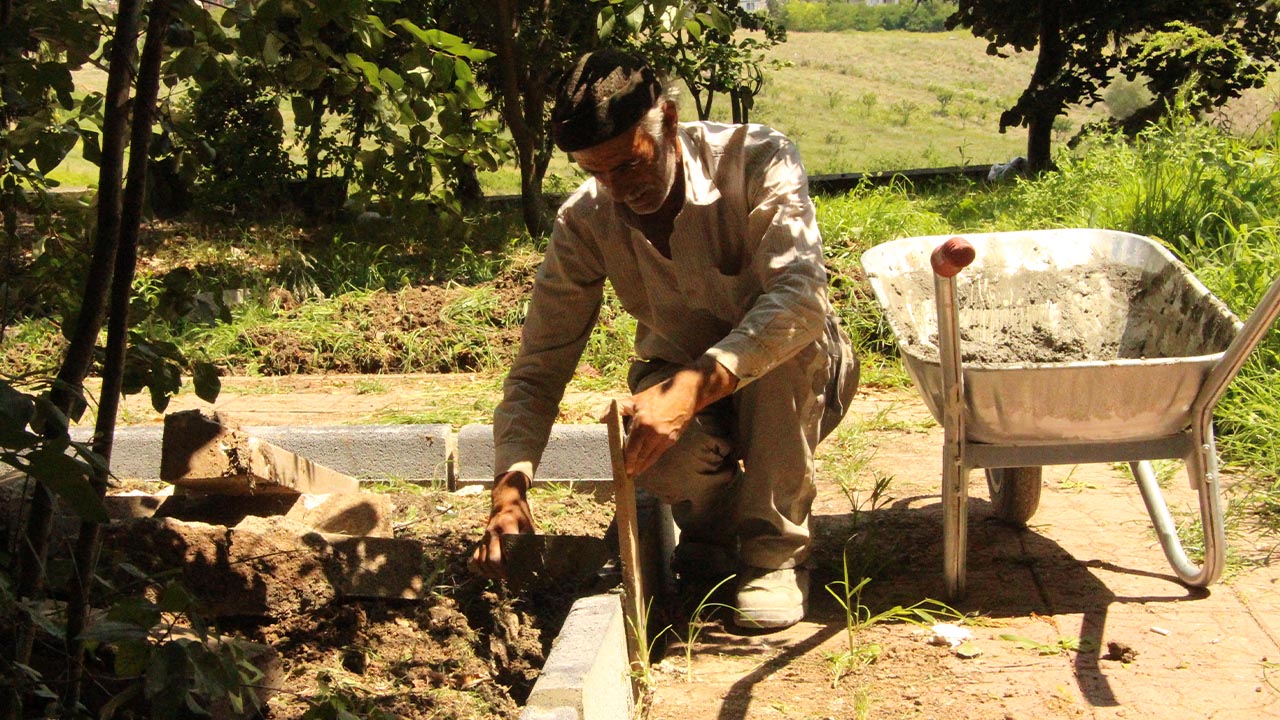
top-left (1129, 420), bottom-right (1226, 588)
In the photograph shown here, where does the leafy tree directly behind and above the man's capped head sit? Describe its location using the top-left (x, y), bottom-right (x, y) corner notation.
top-left (433, 0), bottom-right (782, 234)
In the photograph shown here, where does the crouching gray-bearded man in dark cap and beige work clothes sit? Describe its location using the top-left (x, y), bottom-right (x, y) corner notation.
top-left (472, 49), bottom-right (858, 628)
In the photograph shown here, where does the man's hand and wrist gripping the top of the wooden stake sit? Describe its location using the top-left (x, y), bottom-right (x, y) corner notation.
top-left (618, 355), bottom-right (737, 477)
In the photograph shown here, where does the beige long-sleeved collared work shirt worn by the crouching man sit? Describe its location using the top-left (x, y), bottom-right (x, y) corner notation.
top-left (494, 123), bottom-right (832, 478)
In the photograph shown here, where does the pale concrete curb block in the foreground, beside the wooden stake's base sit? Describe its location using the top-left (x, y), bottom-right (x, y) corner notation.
top-left (520, 594), bottom-right (635, 720)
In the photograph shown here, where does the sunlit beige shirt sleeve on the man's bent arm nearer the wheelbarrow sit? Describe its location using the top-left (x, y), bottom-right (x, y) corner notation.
top-left (707, 133), bottom-right (829, 387)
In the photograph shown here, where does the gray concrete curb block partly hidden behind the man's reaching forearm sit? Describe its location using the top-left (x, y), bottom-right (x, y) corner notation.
top-left (454, 424), bottom-right (613, 500)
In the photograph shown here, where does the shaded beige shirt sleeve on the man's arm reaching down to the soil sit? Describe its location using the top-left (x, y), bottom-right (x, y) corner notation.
top-left (494, 213), bottom-right (604, 478)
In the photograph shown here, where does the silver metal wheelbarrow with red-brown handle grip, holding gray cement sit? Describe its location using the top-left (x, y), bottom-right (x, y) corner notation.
top-left (861, 229), bottom-right (1280, 598)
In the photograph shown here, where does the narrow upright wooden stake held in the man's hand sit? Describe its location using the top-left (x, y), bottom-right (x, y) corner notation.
top-left (605, 400), bottom-right (649, 689)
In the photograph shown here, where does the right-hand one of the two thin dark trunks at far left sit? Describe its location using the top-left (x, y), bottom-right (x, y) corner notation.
top-left (63, 0), bottom-right (170, 707)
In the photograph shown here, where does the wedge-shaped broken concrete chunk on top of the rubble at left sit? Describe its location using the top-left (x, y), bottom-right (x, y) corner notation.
top-left (160, 410), bottom-right (360, 495)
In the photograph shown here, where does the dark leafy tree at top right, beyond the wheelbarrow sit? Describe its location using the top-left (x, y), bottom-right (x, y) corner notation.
top-left (947, 0), bottom-right (1280, 172)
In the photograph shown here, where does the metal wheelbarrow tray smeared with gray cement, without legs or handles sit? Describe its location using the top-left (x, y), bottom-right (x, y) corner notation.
top-left (861, 229), bottom-right (1242, 446)
